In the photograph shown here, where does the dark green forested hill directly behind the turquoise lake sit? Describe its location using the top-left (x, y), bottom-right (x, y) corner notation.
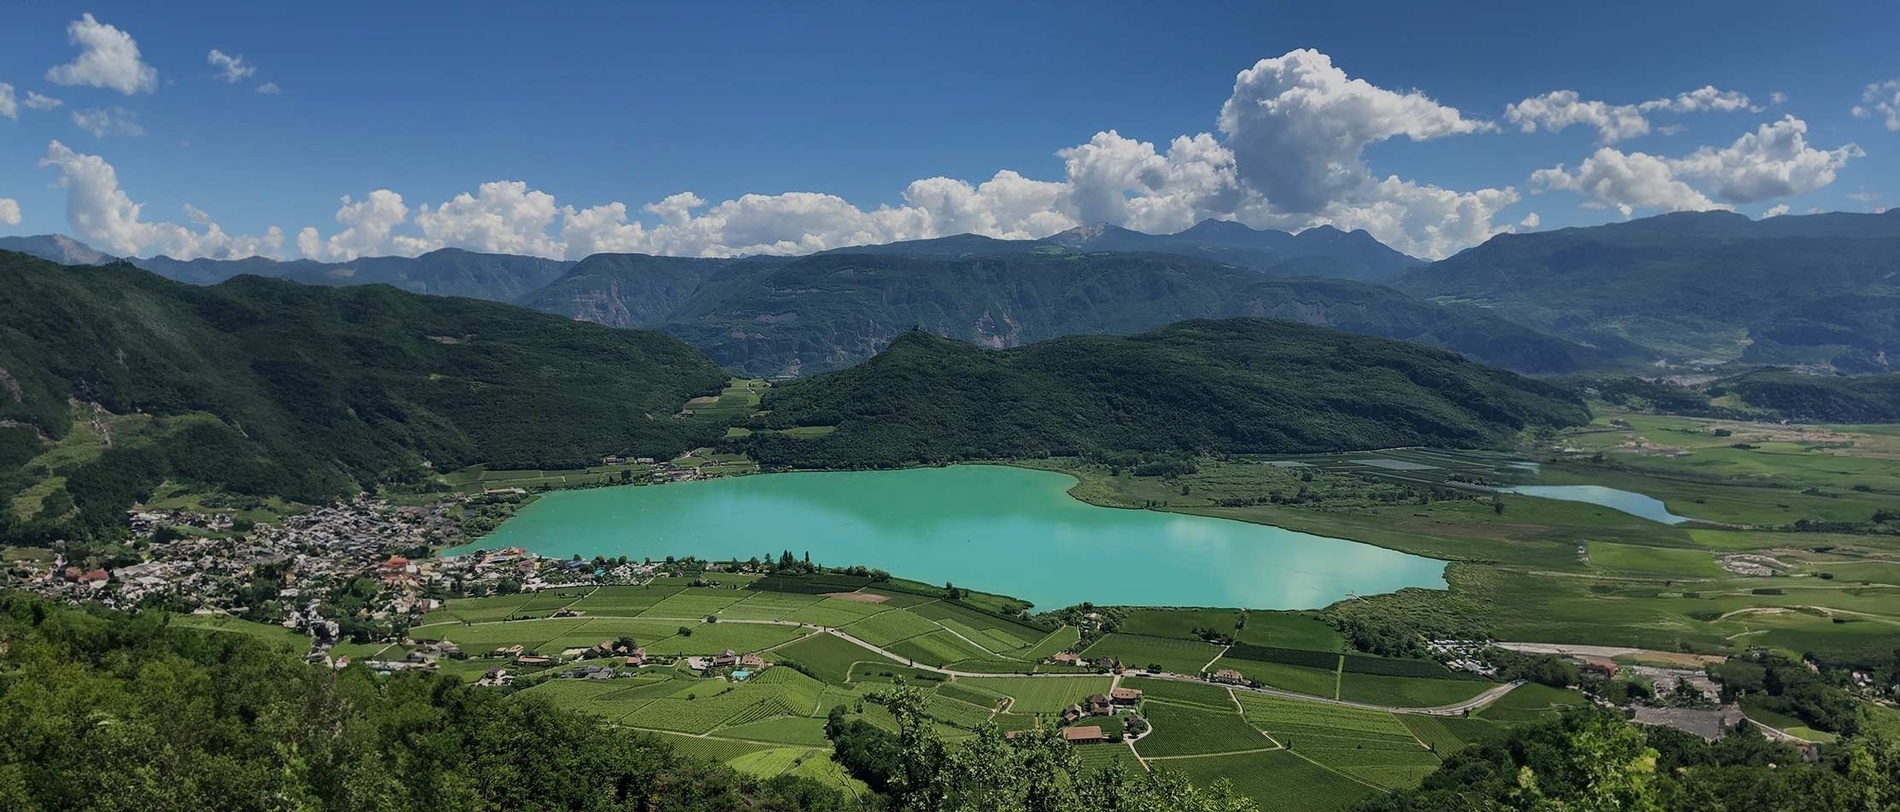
top-left (741, 318), bottom-right (1588, 468)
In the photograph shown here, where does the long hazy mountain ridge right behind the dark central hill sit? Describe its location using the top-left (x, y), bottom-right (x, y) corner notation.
top-left (523, 251), bottom-right (1617, 377)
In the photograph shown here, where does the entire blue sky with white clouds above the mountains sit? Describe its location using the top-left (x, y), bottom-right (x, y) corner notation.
top-left (0, 2), bottom-right (1900, 259)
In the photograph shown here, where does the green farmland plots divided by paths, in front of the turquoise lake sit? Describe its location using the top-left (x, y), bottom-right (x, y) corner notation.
top-left (416, 572), bottom-right (1520, 808)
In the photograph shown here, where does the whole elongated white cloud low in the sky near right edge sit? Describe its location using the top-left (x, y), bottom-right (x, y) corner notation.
top-left (1530, 116), bottom-right (1866, 217)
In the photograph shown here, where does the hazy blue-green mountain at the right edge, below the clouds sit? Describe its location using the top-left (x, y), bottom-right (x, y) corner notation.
top-left (1393, 209), bottom-right (1900, 373)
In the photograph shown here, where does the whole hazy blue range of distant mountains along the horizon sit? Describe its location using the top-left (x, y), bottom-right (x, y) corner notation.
top-left (14, 213), bottom-right (1900, 377)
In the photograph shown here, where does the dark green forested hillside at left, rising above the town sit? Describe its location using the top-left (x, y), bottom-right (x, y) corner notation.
top-left (0, 253), bottom-right (726, 547)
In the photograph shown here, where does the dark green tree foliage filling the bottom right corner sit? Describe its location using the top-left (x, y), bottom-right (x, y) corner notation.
top-left (1359, 709), bottom-right (1900, 812)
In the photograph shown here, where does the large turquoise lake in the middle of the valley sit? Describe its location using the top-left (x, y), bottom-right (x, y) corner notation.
top-left (462, 466), bottom-right (1446, 609)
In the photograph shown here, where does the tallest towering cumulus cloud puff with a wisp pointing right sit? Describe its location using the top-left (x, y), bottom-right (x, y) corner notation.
top-left (1220, 49), bottom-right (1495, 213)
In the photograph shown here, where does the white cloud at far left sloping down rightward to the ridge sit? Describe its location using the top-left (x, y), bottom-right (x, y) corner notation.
top-left (40, 141), bottom-right (283, 259)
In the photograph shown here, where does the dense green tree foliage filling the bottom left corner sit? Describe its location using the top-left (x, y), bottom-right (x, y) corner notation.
top-left (0, 593), bottom-right (857, 812)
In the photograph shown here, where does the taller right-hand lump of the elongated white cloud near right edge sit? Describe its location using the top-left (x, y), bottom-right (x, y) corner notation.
top-left (1672, 116), bottom-right (1866, 203)
